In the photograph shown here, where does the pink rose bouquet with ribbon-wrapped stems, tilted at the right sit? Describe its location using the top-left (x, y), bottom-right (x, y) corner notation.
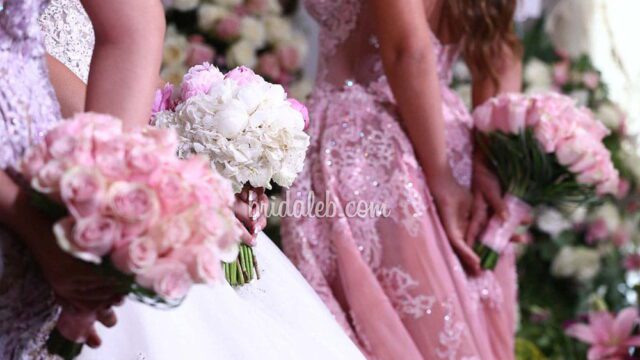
top-left (473, 94), bottom-right (619, 269)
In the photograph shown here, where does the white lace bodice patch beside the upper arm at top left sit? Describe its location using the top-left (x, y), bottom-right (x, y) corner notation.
top-left (40, 0), bottom-right (95, 84)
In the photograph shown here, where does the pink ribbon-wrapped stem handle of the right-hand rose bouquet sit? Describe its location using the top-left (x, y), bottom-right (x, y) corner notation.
top-left (474, 194), bottom-right (531, 270)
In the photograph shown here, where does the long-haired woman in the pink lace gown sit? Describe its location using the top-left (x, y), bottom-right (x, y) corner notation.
top-left (283, 0), bottom-right (521, 359)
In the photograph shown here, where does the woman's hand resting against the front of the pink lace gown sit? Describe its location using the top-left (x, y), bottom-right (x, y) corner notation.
top-left (429, 176), bottom-right (480, 275)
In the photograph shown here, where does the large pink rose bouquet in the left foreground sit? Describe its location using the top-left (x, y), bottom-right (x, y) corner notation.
top-left (21, 113), bottom-right (240, 359)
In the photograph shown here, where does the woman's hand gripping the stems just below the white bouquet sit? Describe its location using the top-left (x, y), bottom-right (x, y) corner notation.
top-left (234, 186), bottom-right (269, 246)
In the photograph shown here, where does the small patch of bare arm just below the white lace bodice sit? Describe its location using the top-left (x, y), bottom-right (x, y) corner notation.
top-left (47, 54), bottom-right (87, 118)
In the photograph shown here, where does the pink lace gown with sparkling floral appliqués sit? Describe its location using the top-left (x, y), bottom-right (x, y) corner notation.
top-left (283, 0), bottom-right (516, 360)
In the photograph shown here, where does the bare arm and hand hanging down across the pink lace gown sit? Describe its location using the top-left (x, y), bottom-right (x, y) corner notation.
top-left (371, 0), bottom-right (480, 273)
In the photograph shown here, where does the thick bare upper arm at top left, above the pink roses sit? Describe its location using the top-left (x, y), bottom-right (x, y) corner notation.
top-left (82, 0), bottom-right (166, 128)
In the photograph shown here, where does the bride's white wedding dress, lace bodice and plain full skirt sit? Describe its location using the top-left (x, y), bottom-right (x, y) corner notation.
top-left (41, 0), bottom-right (364, 360)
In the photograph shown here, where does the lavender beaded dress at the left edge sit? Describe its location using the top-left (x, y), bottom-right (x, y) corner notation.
top-left (0, 0), bottom-right (60, 360)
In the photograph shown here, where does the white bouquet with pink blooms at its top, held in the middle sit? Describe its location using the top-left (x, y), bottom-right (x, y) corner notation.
top-left (152, 63), bottom-right (309, 285)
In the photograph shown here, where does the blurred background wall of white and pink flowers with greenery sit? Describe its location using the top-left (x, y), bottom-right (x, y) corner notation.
top-left (162, 0), bottom-right (640, 359)
